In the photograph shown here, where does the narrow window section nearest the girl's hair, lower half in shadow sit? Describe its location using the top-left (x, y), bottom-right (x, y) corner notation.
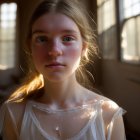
top-left (97, 0), bottom-right (117, 59)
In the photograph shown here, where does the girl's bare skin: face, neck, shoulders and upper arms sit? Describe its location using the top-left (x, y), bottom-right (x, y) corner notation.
top-left (1, 13), bottom-right (124, 140)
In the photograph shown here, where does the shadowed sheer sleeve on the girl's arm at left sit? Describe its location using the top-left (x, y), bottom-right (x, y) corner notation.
top-left (0, 102), bottom-right (18, 140)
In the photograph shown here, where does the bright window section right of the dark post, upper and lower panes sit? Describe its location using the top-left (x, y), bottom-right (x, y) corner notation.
top-left (121, 0), bottom-right (140, 63)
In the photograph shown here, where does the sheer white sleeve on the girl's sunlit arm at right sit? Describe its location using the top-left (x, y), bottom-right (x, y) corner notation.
top-left (107, 107), bottom-right (126, 140)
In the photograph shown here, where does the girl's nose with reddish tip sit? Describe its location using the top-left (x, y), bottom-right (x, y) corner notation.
top-left (48, 41), bottom-right (63, 57)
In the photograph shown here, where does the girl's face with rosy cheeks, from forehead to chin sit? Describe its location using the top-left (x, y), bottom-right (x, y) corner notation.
top-left (31, 13), bottom-right (86, 81)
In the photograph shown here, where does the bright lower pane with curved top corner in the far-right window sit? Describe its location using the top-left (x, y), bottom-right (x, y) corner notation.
top-left (121, 16), bottom-right (140, 62)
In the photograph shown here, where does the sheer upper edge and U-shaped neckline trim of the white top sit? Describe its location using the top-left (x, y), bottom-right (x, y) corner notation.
top-left (29, 100), bottom-right (100, 140)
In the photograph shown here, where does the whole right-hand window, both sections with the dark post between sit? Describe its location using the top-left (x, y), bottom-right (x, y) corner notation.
top-left (97, 0), bottom-right (140, 63)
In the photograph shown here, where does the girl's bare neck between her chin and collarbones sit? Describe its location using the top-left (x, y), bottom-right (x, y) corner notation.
top-left (41, 77), bottom-right (82, 106)
